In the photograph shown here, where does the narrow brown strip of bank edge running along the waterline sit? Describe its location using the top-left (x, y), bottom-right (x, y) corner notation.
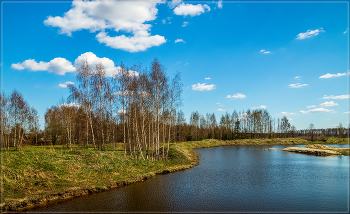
top-left (1, 138), bottom-right (348, 213)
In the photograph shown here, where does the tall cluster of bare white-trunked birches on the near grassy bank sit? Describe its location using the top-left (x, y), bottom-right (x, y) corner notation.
top-left (45, 59), bottom-right (182, 160)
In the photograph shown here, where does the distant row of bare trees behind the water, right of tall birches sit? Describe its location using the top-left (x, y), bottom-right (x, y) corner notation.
top-left (183, 109), bottom-right (296, 140)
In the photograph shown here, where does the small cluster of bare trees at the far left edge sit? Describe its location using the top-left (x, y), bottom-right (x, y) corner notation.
top-left (0, 90), bottom-right (40, 150)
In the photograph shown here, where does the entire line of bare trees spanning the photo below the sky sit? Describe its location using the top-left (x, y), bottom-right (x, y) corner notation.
top-left (0, 59), bottom-right (349, 160)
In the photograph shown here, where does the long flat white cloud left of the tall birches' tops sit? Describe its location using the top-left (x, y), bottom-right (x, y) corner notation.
top-left (11, 57), bottom-right (75, 75)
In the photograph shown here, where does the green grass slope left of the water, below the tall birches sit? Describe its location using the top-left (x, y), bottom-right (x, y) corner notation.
top-left (2, 146), bottom-right (196, 206)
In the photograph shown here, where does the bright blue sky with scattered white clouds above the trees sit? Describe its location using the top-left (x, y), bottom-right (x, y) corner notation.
top-left (1, 1), bottom-right (349, 129)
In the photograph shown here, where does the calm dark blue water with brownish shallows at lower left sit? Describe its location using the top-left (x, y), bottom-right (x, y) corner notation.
top-left (32, 145), bottom-right (349, 213)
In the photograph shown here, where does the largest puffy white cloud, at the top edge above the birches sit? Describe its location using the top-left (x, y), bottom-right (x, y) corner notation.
top-left (44, 0), bottom-right (165, 52)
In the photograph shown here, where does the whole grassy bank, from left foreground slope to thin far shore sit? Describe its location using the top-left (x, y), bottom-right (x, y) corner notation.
top-left (1, 138), bottom-right (347, 210)
